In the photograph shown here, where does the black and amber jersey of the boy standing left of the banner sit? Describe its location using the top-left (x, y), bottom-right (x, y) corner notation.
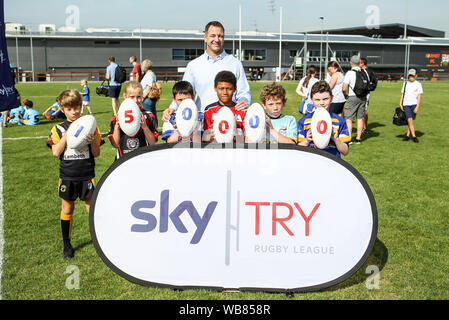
top-left (47, 120), bottom-right (104, 180)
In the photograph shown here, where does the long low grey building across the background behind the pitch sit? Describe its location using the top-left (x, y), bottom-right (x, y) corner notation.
top-left (6, 24), bottom-right (449, 80)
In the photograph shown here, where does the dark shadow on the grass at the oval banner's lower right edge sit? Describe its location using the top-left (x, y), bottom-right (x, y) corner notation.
top-left (323, 238), bottom-right (388, 291)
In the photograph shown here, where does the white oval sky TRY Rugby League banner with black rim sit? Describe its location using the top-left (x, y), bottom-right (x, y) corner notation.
top-left (90, 144), bottom-right (377, 292)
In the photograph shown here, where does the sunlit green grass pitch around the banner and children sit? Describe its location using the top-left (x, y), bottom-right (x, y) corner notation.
top-left (1, 82), bottom-right (449, 300)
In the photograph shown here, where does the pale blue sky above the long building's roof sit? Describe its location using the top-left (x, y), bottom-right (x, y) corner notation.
top-left (5, 0), bottom-right (449, 37)
